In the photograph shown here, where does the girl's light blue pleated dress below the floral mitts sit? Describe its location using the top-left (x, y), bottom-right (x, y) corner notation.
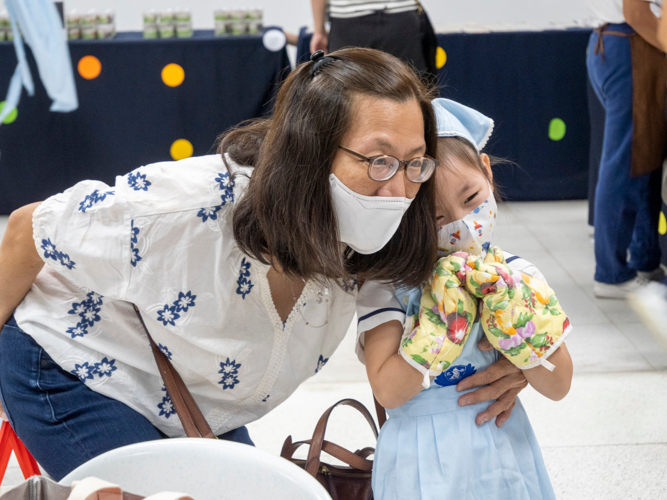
top-left (373, 322), bottom-right (556, 500)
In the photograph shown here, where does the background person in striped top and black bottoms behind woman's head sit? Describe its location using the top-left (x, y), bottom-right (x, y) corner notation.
top-left (310, 0), bottom-right (431, 72)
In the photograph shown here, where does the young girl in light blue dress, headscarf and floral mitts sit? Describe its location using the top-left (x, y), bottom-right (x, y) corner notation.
top-left (358, 99), bottom-right (572, 500)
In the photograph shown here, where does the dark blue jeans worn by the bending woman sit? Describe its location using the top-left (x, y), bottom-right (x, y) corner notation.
top-left (0, 318), bottom-right (253, 481)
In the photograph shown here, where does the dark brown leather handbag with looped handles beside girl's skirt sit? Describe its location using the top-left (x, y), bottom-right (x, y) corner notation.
top-left (280, 399), bottom-right (384, 500)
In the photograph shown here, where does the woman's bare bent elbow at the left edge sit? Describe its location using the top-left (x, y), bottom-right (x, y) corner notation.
top-left (0, 203), bottom-right (44, 328)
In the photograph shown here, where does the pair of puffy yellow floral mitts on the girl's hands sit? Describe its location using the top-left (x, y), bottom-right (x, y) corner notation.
top-left (399, 247), bottom-right (571, 387)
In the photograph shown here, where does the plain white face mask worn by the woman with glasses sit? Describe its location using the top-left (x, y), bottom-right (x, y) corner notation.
top-left (329, 174), bottom-right (412, 255)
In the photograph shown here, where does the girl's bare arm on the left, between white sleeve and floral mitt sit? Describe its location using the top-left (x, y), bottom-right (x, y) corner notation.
top-left (364, 321), bottom-right (424, 410)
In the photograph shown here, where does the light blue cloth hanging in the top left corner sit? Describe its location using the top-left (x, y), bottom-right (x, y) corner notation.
top-left (0, 0), bottom-right (79, 123)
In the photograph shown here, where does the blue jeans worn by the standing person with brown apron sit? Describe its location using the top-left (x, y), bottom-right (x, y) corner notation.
top-left (586, 24), bottom-right (660, 284)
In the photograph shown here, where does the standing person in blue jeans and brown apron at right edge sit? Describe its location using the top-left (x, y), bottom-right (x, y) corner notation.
top-left (587, 0), bottom-right (667, 298)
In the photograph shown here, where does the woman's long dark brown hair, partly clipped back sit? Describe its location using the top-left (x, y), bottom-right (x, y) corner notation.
top-left (218, 48), bottom-right (437, 286)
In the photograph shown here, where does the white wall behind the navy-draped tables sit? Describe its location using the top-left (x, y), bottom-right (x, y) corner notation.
top-left (56, 0), bottom-right (588, 32)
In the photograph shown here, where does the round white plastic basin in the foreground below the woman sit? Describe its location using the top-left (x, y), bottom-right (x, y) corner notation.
top-left (60, 438), bottom-right (331, 500)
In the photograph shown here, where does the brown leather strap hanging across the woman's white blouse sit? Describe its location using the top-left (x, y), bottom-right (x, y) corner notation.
top-left (132, 304), bottom-right (217, 439)
